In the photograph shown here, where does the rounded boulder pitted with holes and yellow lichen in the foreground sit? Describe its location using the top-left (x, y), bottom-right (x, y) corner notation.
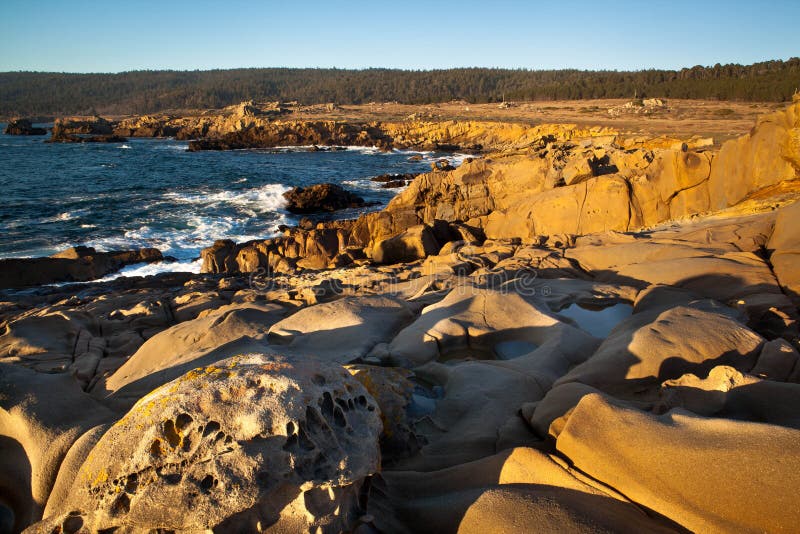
top-left (31, 354), bottom-right (388, 532)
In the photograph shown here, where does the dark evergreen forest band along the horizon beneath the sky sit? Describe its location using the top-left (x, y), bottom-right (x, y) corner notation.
top-left (0, 58), bottom-right (800, 117)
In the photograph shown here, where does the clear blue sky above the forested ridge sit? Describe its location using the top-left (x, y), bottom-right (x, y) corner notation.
top-left (0, 0), bottom-right (800, 72)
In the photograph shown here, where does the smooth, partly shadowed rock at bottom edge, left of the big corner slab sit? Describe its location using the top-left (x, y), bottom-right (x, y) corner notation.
top-left (369, 448), bottom-right (670, 532)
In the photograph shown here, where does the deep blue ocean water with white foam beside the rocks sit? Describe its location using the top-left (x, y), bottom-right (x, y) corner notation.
top-left (0, 125), bottom-right (457, 274)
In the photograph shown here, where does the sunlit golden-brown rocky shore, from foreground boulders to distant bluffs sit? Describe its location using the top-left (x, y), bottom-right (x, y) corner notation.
top-left (0, 97), bottom-right (800, 534)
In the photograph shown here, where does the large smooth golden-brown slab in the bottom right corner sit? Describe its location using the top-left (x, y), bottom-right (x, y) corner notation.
top-left (556, 394), bottom-right (800, 532)
